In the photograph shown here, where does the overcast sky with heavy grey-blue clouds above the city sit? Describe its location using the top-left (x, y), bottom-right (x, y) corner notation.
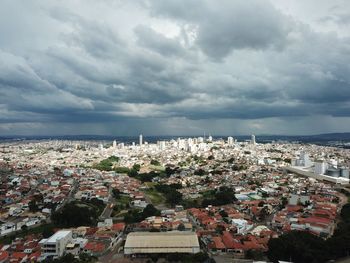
top-left (0, 0), bottom-right (350, 136)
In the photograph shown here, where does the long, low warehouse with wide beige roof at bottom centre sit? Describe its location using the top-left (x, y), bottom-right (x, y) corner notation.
top-left (124, 231), bottom-right (200, 255)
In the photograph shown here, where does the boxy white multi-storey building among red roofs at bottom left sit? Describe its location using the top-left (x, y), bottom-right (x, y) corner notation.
top-left (39, 230), bottom-right (72, 258)
